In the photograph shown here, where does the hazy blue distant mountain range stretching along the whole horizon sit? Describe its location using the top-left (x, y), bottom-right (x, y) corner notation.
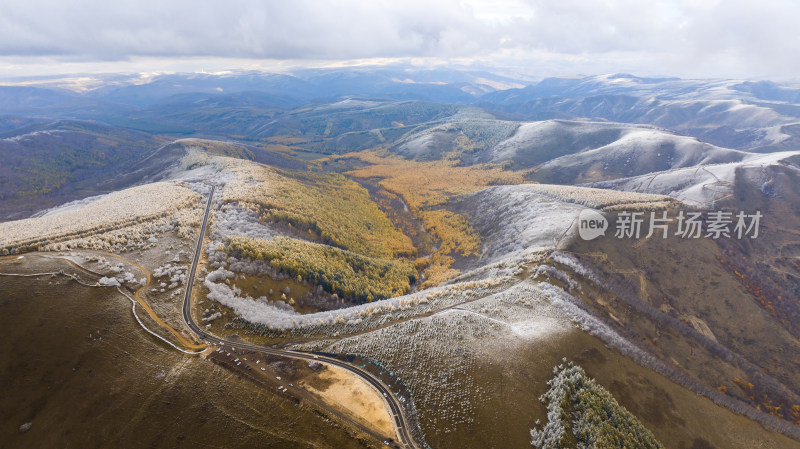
top-left (0, 67), bottom-right (800, 152)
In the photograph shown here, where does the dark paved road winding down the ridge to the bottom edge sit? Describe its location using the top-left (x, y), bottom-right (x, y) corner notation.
top-left (183, 186), bottom-right (418, 449)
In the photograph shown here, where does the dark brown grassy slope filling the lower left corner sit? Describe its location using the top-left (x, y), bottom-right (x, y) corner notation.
top-left (0, 259), bottom-right (384, 449)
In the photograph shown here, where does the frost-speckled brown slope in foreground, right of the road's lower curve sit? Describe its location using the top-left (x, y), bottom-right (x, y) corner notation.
top-left (297, 282), bottom-right (588, 433)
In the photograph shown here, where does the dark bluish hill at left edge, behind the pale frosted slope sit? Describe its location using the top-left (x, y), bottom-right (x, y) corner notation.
top-left (0, 120), bottom-right (164, 220)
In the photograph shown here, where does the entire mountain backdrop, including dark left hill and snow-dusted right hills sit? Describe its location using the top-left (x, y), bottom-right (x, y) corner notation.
top-left (0, 67), bottom-right (800, 219)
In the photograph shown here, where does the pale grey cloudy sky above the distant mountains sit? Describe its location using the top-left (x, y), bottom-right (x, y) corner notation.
top-left (0, 0), bottom-right (800, 80)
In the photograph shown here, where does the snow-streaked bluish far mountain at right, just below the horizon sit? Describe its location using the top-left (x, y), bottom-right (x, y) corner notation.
top-left (479, 74), bottom-right (800, 152)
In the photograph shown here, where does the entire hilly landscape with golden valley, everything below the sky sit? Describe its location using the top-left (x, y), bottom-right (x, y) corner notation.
top-left (0, 69), bottom-right (800, 449)
